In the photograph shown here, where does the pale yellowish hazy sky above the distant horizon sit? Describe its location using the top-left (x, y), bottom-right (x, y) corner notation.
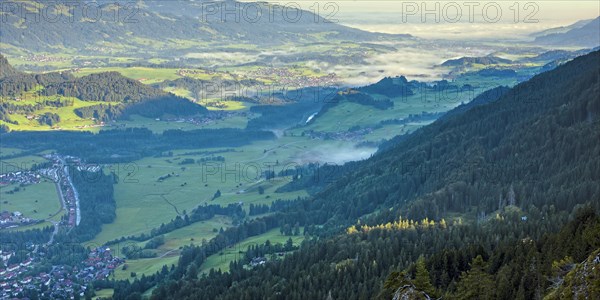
top-left (248, 0), bottom-right (600, 39)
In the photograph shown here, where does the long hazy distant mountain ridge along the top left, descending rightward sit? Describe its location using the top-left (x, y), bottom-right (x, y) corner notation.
top-left (0, 0), bottom-right (408, 53)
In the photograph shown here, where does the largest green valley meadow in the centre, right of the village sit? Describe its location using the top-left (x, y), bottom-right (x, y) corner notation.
top-left (89, 137), bottom-right (352, 244)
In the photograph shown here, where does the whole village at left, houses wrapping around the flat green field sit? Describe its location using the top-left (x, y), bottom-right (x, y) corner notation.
top-left (0, 154), bottom-right (124, 299)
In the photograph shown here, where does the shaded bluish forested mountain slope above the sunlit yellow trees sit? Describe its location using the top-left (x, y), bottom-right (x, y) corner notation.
top-left (302, 51), bottom-right (600, 227)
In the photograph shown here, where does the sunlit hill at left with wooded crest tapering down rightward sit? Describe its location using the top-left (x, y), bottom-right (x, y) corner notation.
top-left (0, 55), bottom-right (208, 131)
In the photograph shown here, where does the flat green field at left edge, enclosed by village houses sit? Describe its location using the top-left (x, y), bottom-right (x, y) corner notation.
top-left (0, 181), bottom-right (60, 220)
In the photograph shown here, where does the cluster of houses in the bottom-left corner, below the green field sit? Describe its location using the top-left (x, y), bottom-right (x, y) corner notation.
top-left (0, 247), bottom-right (124, 299)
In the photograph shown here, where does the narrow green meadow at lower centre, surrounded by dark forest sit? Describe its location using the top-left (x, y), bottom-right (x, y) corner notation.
top-left (200, 228), bottom-right (305, 272)
